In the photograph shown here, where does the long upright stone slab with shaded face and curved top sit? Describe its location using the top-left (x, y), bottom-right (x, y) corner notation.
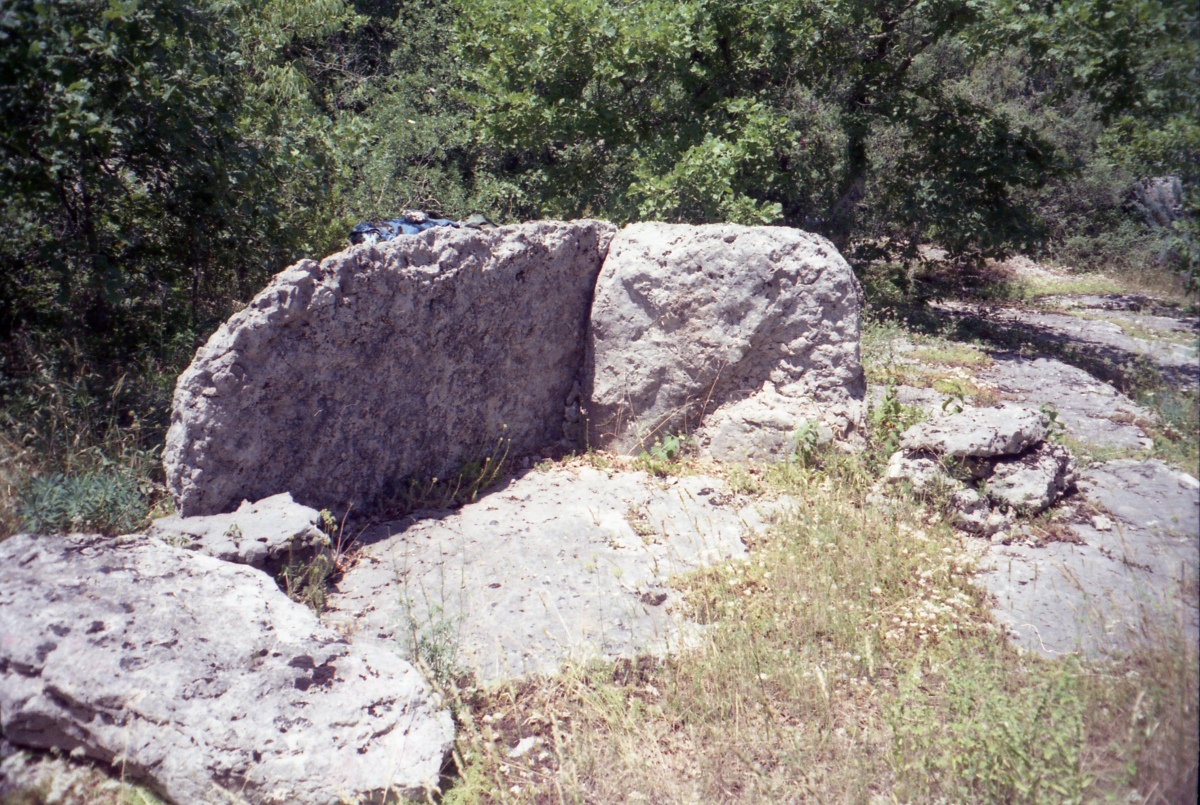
top-left (163, 221), bottom-right (619, 516)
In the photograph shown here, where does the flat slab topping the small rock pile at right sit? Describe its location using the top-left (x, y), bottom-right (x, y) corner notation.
top-left (900, 405), bottom-right (1046, 458)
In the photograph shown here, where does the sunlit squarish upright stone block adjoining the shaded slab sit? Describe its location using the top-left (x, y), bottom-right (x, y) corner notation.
top-left (584, 223), bottom-right (865, 459)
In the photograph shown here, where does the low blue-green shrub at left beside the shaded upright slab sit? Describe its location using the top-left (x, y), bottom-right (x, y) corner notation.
top-left (18, 469), bottom-right (150, 534)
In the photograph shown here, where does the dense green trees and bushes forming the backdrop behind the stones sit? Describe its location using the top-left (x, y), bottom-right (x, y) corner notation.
top-left (0, 0), bottom-right (1200, 527)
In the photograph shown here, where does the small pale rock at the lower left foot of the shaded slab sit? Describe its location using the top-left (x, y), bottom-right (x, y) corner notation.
top-left (146, 492), bottom-right (328, 572)
